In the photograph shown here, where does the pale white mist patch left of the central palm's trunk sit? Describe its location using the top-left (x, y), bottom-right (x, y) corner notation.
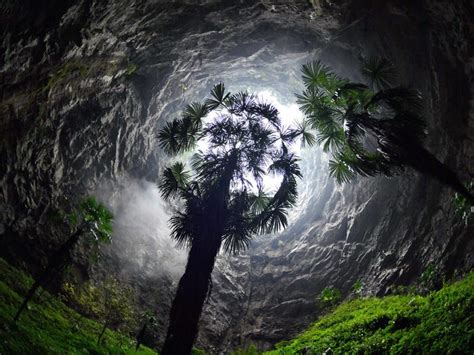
top-left (94, 178), bottom-right (186, 279)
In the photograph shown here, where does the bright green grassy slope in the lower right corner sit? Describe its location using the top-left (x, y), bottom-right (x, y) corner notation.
top-left (266, 272), bottom-right (474, 355)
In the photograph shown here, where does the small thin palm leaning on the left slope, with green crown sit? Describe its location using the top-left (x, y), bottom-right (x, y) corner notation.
top-left (13, 197), bottom-right (113, 322)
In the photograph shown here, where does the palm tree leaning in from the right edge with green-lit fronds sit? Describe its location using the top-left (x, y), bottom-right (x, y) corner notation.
top-left (297, 59), bottom-right (474, 204)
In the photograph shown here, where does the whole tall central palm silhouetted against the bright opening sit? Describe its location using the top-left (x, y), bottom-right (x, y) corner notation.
top-left (158, 84), bottom-right (314, 355)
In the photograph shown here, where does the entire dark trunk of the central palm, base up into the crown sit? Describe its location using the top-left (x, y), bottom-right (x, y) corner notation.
top-left (160, 150), bottom-right (238, 355)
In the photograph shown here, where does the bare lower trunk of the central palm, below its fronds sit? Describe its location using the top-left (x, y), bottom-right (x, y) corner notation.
top-left (161, 237), bottom-right (221, 355)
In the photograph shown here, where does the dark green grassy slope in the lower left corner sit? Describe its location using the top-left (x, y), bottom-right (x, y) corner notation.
top-left (0, 259), bottom-right (155, 355)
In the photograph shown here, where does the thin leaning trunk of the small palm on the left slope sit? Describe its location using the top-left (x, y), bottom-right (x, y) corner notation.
top-left (13, 229), bottom-right (82, 322)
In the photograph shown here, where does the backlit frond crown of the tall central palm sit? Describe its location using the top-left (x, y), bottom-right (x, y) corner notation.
top-left (158, 83), bottom-right (310, 253)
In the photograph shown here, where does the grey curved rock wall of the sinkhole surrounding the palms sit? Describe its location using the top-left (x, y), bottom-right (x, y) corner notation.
top-left (0, 0), bottom-right (474, 352)
